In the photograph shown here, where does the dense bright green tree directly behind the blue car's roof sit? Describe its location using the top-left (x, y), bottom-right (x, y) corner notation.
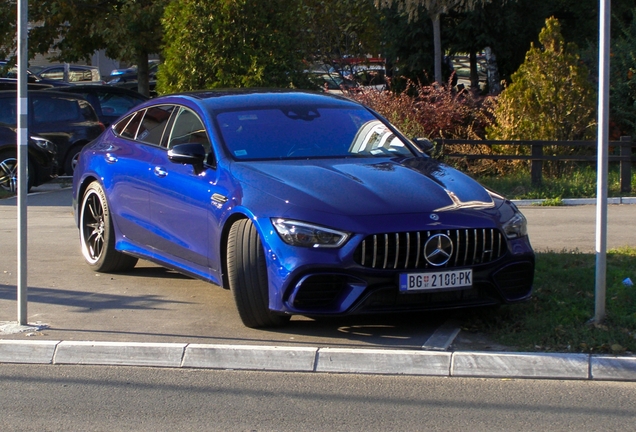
top-left (157, 0), bottom-right (309, 93)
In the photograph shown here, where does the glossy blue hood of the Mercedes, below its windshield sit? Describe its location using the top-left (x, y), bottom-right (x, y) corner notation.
top-left (231, 158), bottom-right (495, 215)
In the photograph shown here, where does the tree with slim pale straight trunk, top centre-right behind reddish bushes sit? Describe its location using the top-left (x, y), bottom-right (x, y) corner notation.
top-left (375, 0), bottom-right (491, 83)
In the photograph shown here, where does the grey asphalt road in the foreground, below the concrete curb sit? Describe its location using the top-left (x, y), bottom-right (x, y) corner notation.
top-left (0, 364), bottom-right (636, 432)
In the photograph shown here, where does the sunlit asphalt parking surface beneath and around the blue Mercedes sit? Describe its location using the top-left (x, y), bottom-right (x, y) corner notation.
top-left (0, 185), bottom-right (636, 349)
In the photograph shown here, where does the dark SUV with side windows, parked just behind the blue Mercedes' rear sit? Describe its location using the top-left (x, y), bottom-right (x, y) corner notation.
top-left (0, 90), bottom-right (104, 175)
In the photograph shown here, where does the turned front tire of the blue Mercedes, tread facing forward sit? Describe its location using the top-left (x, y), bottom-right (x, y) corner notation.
top-left (227, 219), bottom-right (291, 328)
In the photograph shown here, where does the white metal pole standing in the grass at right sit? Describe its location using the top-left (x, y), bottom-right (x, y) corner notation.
top-left (594, 0), bottom-right (611, 323)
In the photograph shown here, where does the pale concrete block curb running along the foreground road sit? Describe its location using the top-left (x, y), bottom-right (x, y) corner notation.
top-left (0, 340), bottom-right (636, 381)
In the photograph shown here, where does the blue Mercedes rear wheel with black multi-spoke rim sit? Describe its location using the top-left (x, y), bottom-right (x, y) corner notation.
top-left (79, 182), bottom-right (137, 273)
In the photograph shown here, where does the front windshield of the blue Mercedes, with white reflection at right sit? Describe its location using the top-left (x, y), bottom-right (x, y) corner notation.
top-left (216, 106), bottom-right (413, 160)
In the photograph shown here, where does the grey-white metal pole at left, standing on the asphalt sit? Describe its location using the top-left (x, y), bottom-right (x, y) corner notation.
top-left (17, 0), bottom-right (29, 325)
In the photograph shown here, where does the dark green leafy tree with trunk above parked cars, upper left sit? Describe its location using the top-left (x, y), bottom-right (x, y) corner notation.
top-left (0, 0), bottom-right (167, 95)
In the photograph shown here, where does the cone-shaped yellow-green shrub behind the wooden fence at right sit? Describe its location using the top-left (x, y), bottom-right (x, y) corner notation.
top-left (488, 18), bottom-right (596, 141)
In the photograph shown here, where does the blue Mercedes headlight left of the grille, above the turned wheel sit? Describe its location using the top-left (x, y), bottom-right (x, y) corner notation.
top-left (272, 219), bottom-right (349, 248)
